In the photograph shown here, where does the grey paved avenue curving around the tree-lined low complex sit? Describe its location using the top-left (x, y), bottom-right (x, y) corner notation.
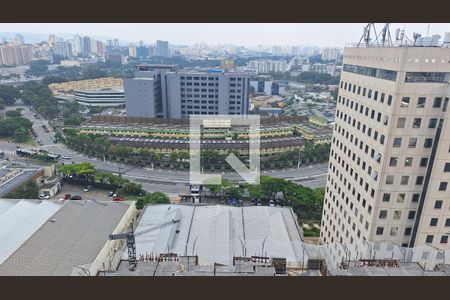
top-left (0, 107), bottom-right (327, 195)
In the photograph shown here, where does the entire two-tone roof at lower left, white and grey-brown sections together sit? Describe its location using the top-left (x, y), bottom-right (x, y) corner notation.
top-left (0, 200), bottom-right (129, 276)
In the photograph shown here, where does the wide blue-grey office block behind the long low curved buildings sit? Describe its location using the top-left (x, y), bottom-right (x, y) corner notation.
top-left (124, 65), bottom-right (250, 119)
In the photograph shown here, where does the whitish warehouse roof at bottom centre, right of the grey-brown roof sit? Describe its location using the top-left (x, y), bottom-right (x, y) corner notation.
top-left (123, 204), bottom-right (306, 265)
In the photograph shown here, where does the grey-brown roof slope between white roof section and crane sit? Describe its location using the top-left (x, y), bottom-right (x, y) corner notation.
top-left (0, 200), bottom-right (129, 276)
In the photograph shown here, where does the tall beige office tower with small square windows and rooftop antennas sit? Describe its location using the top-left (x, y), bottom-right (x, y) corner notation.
top-left (320, 41), bottom-right (450, 259)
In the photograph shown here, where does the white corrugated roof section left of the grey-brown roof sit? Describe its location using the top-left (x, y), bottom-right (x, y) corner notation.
top-left (0, 200), bottom-right (61, 265)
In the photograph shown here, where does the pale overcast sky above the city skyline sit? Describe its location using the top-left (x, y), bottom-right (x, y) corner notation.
top-left (0, 23), bottom-right (450, 47)
